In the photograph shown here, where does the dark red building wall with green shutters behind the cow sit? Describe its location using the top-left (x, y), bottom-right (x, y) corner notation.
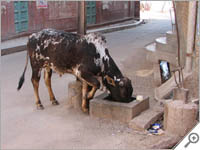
top-left (1, 1), bottom-right (138, 40)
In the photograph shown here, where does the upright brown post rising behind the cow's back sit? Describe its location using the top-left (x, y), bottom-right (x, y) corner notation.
top-left (77, 1), bottom-right (86, 34)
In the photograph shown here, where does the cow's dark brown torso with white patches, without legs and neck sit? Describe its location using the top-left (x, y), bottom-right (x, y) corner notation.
top-left (27, 29), bottom-right (99, 74)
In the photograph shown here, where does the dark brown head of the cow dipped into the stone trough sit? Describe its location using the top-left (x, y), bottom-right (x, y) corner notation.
top-left (105, 76), bottom-right (133, 102)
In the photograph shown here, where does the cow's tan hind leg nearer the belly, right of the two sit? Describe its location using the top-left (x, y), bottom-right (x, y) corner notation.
top-left (44, 68), bottom-right (59, 105)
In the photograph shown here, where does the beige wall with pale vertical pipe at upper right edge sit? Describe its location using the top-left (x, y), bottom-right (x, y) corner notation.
top-left (175, 1), bottom-right (197, 69)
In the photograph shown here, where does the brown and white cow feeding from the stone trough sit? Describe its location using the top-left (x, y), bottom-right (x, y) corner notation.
top-left (17, 29), bottom-right (133, 112)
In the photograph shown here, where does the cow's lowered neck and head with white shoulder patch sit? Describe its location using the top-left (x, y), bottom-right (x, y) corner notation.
top-left (84, 33), bottom-right (133, 102)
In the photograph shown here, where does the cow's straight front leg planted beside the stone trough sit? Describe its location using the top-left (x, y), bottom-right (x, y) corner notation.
top-left (82, 81), bottom-right (88, 112)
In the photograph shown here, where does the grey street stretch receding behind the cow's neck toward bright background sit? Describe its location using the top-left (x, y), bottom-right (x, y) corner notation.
top-left (105, 20), bottom-right (171, 61)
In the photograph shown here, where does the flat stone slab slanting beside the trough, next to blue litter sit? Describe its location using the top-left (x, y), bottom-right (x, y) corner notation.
top-left (129, 105), bottom-right (164, 131)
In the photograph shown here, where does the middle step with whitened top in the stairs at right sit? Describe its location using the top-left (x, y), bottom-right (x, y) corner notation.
top-left (155, 37), bottom-right (176, 53)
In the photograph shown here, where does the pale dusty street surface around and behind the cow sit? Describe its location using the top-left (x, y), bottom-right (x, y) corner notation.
top-left (1, 20), bottom-right (171, 149)
